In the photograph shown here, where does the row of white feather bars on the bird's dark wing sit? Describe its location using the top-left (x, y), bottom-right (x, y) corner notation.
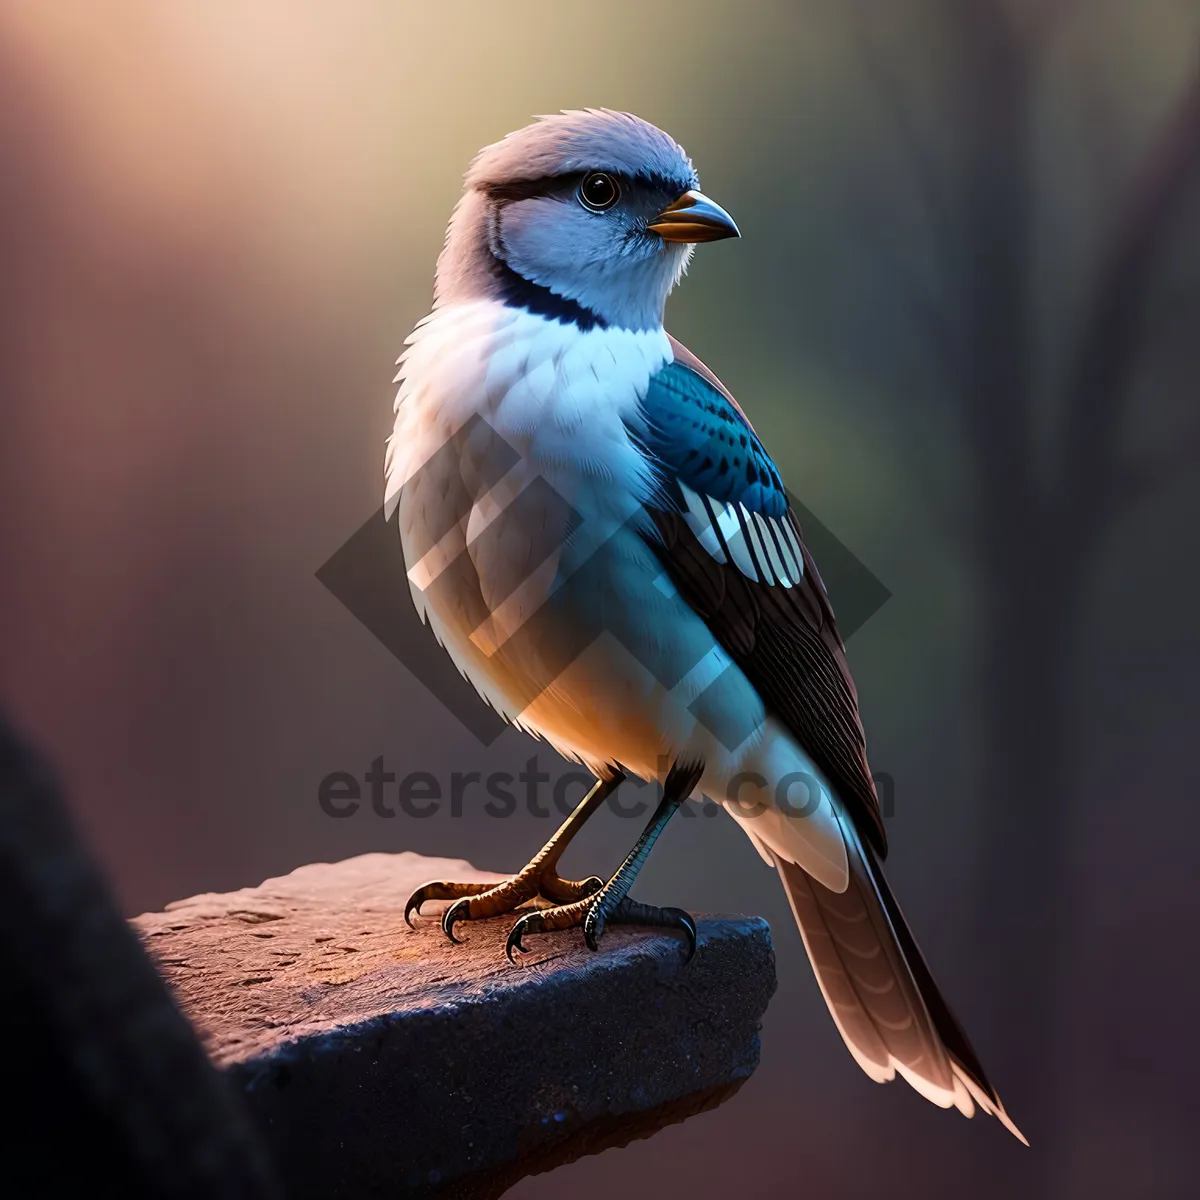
top-left (679, 484), bottom-right (804, 588)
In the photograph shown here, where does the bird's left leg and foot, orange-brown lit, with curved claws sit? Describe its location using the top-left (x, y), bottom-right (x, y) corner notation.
top-left (404, 770), bottom-right (625, 941)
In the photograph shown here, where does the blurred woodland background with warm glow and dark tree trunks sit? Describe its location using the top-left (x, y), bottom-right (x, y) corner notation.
top-left (0, 0), bottom-right (1200, 1200)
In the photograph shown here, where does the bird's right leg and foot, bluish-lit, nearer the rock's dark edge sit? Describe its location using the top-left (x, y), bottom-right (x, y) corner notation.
top-left (505, 762), bottom-right (704, 962)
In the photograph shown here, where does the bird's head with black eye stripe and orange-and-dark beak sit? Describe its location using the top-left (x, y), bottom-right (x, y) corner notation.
top-left (437, 109), bottom-right (738, 329)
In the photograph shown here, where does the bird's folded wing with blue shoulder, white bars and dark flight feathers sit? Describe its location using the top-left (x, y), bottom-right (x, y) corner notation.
top-left (630, 340), bottom-right (887, 857)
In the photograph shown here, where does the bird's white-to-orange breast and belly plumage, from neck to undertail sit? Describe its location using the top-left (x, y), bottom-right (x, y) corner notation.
top-left (386, 291), bottom-right (846, 888)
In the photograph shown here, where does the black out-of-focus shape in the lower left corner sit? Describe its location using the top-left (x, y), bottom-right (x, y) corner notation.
top-left (0, 715), bottom-right (281, 1200)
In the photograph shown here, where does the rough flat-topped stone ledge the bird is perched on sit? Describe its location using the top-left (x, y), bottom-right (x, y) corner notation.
top-left (134, 854), bottom-right (775, 1200)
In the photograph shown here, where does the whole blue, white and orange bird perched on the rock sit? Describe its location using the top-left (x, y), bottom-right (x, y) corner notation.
top-left (384, 108), bottom-right (1027, 1144)
